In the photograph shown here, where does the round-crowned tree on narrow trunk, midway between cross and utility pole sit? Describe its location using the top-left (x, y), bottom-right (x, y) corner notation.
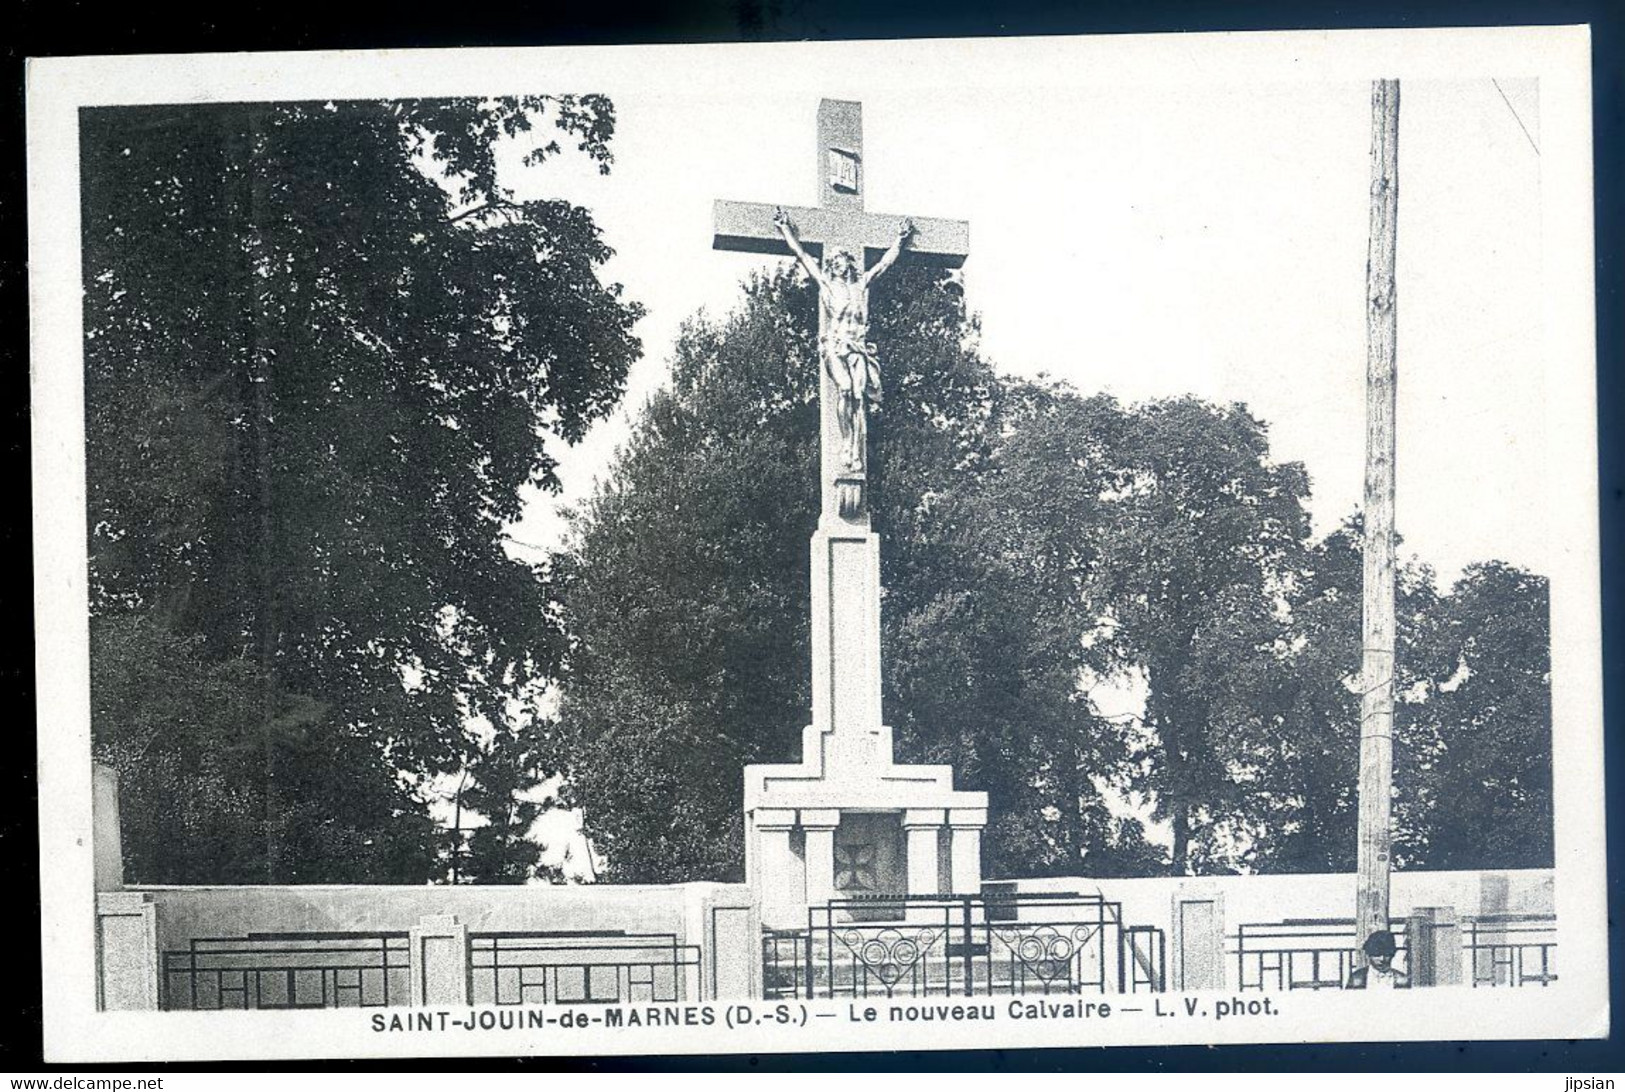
top-left (1087, 398), bottom-right (1308, 874)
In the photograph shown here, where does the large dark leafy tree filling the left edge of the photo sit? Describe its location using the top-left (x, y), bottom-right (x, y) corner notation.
top-left (81, 96), bottom-right (640, 881)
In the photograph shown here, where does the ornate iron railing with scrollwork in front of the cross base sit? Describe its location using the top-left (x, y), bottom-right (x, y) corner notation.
top-left (762, 892), bottom-right (1165, 998)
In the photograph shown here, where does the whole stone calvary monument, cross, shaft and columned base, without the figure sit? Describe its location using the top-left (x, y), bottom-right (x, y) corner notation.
top-left (713, 99), bottom-right (988, 926)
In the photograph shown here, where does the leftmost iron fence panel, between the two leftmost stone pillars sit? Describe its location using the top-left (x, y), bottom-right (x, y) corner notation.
top-left (161, 933), bottom-right (411, 1009)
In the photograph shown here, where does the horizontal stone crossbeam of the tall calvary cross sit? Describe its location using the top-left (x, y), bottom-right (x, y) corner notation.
top-left (712, 202), bottom-right (970, 270)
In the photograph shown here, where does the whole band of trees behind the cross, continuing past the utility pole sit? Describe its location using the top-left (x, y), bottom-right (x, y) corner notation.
top-left (553, 267), bottom-right (1550, 881)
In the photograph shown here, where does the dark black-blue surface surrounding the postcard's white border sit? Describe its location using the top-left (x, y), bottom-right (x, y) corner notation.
top-left (0, 0), bottom-right (1625, 1087)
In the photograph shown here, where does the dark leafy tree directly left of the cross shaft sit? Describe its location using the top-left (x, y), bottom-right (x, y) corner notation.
top-left (556, 268), bottom-right (817, 882)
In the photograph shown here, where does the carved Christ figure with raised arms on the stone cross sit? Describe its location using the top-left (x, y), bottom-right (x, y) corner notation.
top-left (774, 208), bottom-right (913, 475)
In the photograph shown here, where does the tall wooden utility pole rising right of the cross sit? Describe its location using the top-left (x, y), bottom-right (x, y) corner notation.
top-left (1354, 80), bottom-right (1399, 967)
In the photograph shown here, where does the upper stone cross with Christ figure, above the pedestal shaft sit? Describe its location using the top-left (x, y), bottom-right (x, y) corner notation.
top-left (712, 99), bottom-right (970, 523)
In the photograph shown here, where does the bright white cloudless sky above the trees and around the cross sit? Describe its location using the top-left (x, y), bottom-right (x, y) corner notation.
top-left (509, 74), bottom-right (1549, 580)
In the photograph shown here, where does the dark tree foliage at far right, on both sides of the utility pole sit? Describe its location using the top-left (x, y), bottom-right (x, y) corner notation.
top-left (1233, 518), bottom-right (1554, 871)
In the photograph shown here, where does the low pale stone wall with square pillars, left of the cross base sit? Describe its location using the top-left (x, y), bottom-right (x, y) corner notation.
top-left (99, 884), bottom-right (761, 1008)
